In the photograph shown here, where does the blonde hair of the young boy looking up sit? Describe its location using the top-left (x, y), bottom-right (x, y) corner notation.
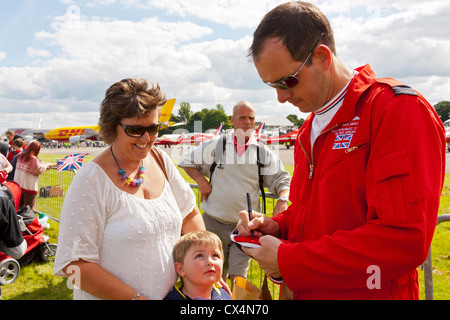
top-left (173, 230), bottom-right (223, 263)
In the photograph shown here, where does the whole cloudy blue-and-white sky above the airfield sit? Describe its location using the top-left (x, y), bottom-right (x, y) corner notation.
top-left (0, 0), bottom-right (450, 133)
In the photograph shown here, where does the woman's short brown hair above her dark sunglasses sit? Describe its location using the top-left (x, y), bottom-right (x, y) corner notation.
top-left (99, 79), bottom-right (166, 144)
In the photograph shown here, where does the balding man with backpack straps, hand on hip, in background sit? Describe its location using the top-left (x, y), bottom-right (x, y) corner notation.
top-left (178, 101), bottom-right (290, 281)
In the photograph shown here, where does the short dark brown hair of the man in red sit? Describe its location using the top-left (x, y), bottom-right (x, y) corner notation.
top-left (249, 1), bottom-right (336, 65)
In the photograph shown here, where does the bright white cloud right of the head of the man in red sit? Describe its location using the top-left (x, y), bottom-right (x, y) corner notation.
top-left (322, 0), bottom-right (450, 104)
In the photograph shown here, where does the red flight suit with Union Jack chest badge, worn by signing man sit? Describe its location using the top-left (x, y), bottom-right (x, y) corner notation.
top-left (273, 65), bottom-right (445, 299)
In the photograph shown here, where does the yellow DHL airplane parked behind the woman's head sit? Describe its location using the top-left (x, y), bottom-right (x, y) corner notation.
top-left (34, 99), bottom-right (176, 143)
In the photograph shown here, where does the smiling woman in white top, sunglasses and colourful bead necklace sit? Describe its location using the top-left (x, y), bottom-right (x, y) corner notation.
top-left (54, 79), bottom-right (204, 300)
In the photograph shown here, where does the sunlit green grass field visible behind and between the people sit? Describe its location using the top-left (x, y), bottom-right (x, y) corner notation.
top-left (1, 154), bottom-right (450, 300)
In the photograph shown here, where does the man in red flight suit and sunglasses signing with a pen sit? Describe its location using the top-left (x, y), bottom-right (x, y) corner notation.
top-left (238, 1), bottom-right (445, 299)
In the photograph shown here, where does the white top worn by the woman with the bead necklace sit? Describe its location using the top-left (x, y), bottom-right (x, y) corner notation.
top-left (54, 152), bottom-right (195, 300)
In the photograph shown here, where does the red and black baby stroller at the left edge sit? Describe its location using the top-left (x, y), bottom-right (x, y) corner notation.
top-left (0, 181), bottom-right (57, 286)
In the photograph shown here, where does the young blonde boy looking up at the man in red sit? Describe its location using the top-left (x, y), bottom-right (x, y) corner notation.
top-left (164, 230), bottom-right (231, 300)
